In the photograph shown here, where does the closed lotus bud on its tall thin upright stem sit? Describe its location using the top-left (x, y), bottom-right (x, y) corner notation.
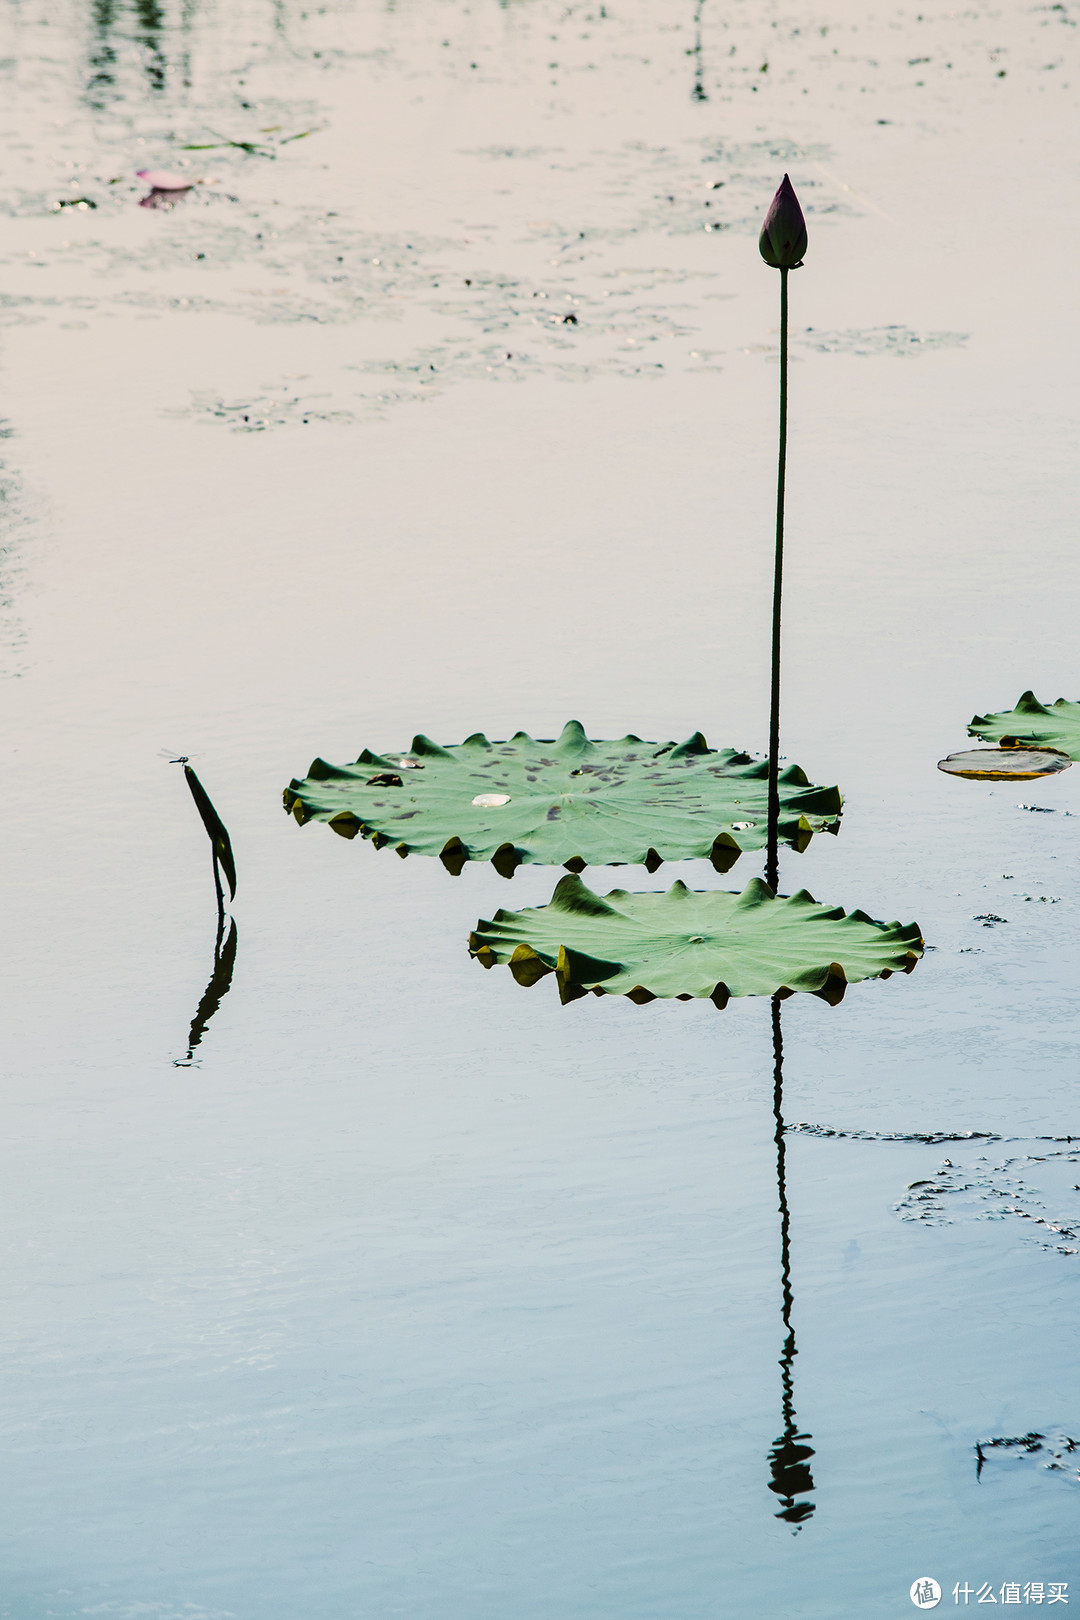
top-left (758, 175), bottom-right (806, 894)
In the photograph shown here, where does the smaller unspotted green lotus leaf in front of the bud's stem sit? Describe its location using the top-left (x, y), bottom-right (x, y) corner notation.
top-left (470, 876), bottom-right (923, 1008)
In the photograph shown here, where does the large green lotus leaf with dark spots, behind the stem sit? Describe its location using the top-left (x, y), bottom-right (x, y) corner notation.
top-left (285, 721), bottom-right (842, 878)
